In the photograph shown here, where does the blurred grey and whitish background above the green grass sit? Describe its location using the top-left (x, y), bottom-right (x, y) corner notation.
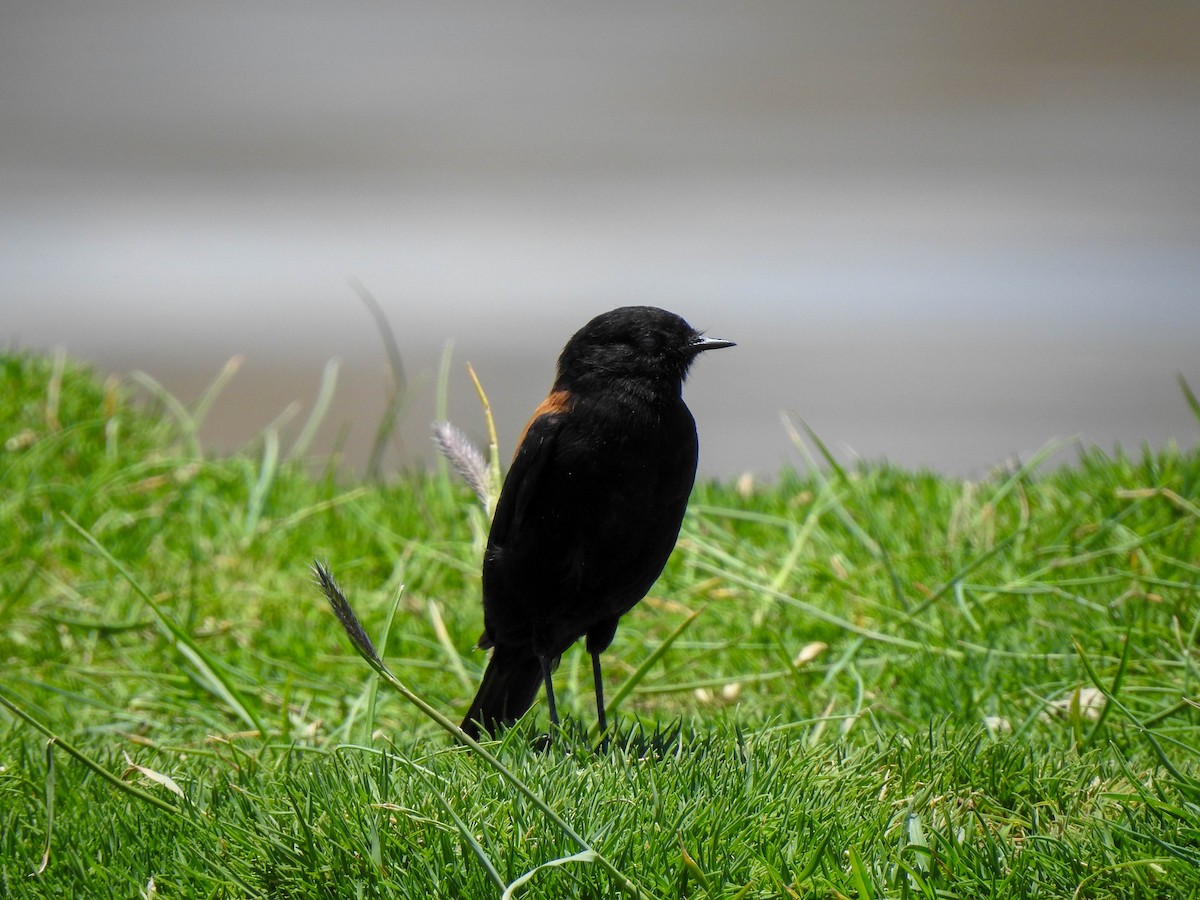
top-left (0, 0), bottom-right (1200, 476)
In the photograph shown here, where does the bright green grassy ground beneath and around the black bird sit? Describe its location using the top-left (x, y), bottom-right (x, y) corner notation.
top-left (0, 354), bottom-right (1200, 898)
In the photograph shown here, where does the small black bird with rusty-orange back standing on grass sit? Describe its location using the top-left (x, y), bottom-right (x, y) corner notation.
top-left (462, 306), bottom-right (733, 737)
